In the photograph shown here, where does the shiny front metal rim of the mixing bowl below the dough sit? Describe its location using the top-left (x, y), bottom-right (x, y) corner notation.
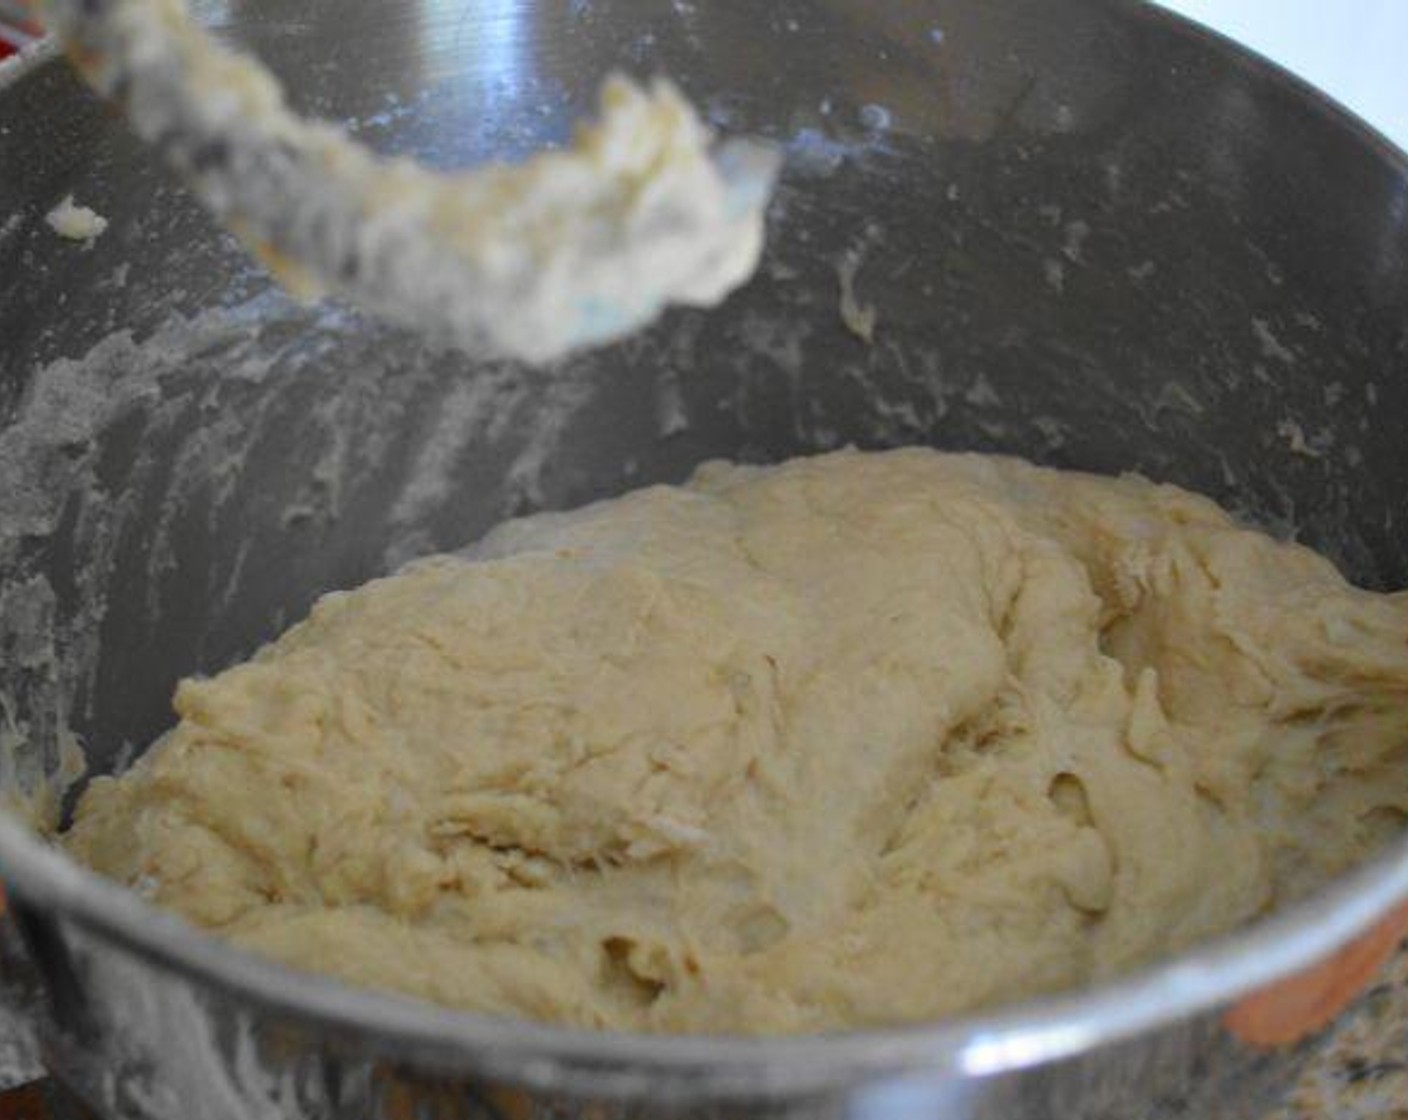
top-left (0, 811), bottom-right (1408, 1095)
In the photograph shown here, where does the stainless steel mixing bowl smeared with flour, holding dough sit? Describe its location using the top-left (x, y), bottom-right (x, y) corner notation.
top-left (0, 0), bottom-right (1408, 1120)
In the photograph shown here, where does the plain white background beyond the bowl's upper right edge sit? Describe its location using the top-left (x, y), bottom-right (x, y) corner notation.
top-left (1162, 0), bottom-right (1408, 148)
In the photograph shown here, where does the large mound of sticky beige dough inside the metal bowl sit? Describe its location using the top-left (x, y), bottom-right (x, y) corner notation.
top-left (65, 449), bottom-right (1408, 1033)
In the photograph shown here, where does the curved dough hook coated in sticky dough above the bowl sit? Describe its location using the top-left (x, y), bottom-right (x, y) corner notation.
top-left (38, 0), bottom-right (779, 362)
